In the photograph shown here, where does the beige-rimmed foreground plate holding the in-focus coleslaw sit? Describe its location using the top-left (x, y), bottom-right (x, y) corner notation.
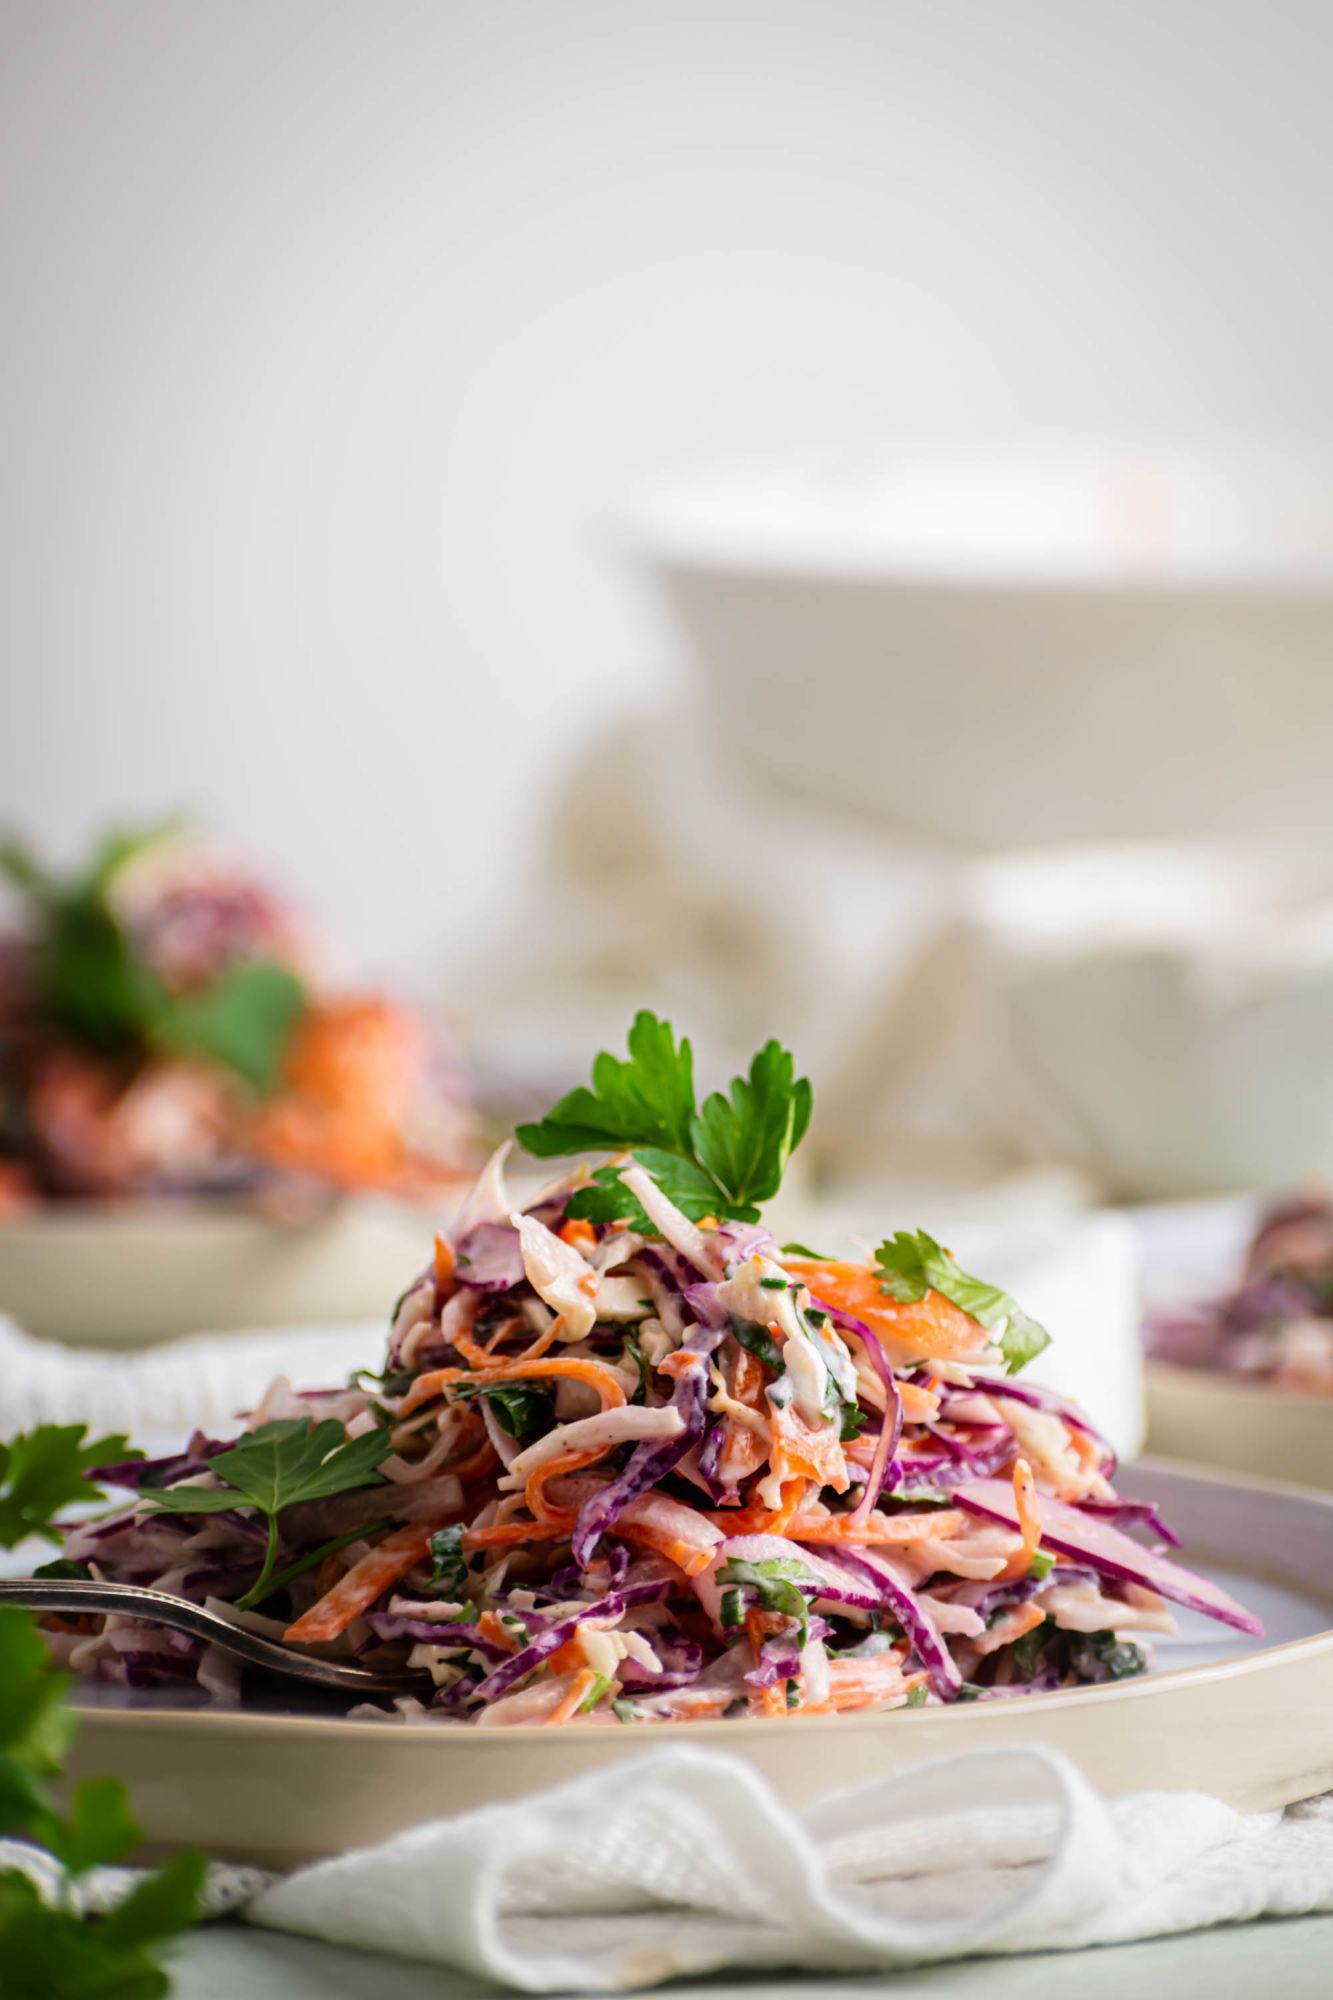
top-left (65, 1464), bottom-right (1333, 1866)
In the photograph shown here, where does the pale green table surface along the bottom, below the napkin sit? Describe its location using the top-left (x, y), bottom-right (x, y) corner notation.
top-left (174, 1916), bottom-right (1333, 2000)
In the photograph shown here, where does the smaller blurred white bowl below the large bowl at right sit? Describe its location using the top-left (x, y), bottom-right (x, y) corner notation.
top-left (953, 846), bottom-right (1333, 1198)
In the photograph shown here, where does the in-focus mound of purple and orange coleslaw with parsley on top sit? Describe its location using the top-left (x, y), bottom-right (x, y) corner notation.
top-left (36, 1014), bottom-right (1261, 1728)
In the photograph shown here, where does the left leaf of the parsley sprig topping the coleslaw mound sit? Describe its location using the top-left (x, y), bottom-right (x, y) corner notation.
top-left (516, 1008), bottom-right (695, 1160)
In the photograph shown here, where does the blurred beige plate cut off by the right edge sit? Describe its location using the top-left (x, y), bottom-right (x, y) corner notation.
top-left (1145, 1362), bottom-right (1333, 1492)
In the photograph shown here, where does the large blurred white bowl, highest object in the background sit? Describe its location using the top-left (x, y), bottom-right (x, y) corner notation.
top-left (630, 450), bottom-right (1333, 850)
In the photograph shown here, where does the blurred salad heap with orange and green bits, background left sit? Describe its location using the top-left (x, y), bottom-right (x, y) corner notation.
top-left (0, 822), bottom-right (474, 1214)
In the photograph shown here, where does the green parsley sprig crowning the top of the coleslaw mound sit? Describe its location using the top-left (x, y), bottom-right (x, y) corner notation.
top-left (518, 1010), bottom-right (813, 1232)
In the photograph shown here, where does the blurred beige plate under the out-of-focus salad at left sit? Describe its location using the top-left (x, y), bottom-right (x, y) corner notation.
top-left (0, 1200), bottom-right (448, 1348)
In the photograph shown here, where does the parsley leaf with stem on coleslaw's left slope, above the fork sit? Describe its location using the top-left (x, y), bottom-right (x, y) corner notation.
top-left (142, 1416), bottom-right (392, 1610)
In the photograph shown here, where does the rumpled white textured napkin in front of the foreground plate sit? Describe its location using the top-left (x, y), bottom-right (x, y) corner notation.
top-left (248, 1724), bottom-right (1333, 1992)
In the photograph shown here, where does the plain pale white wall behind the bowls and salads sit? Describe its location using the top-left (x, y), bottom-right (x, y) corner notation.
top-left (0, 0), bottom-right (1333, 996)
